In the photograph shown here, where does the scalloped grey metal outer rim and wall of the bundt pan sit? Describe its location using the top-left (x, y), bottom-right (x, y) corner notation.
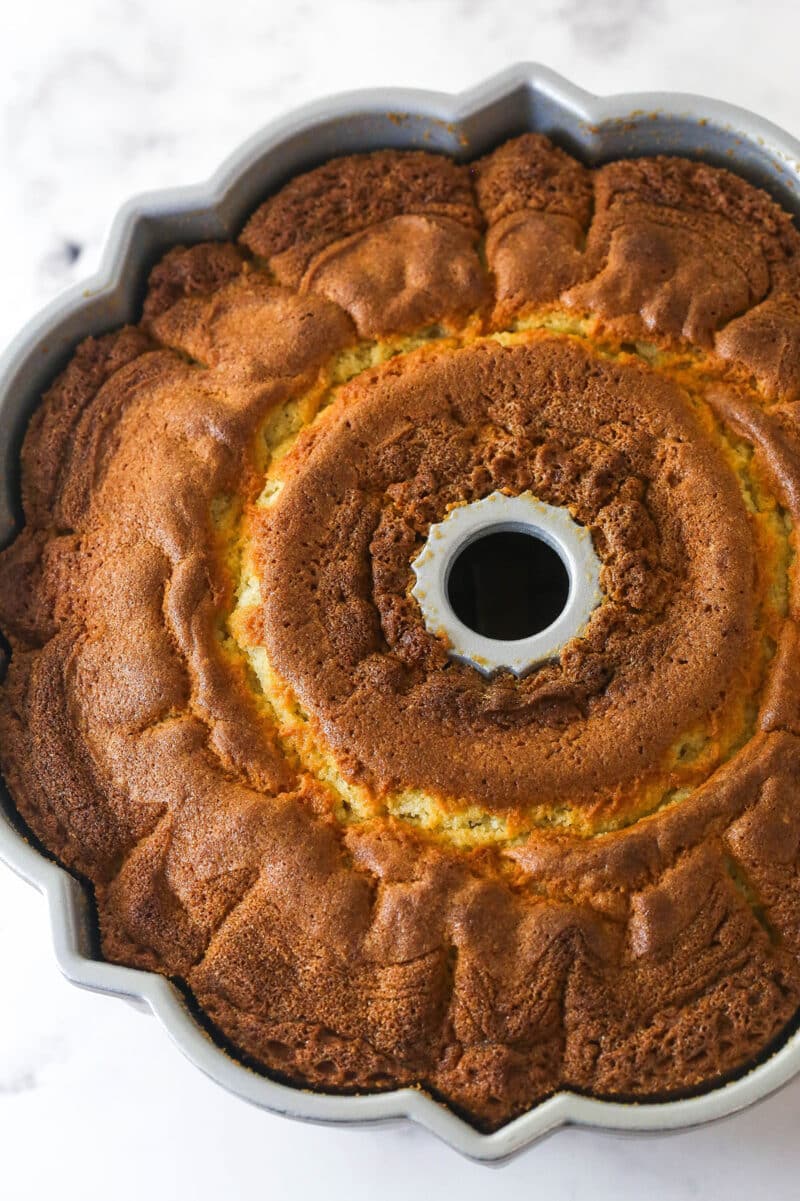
top-left (0, 65), bottom-right (800, 1161)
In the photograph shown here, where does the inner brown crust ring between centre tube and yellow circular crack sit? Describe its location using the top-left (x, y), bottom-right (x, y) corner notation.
top-left (256, 336), bottom-right (756, 808)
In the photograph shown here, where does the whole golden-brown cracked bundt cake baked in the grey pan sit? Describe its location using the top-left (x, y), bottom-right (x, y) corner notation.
top-left (0, 135), bottom-right (800, 1130)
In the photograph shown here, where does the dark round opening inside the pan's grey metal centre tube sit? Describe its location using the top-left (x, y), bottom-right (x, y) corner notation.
top-left (447, 530), bottom-right (569, 641)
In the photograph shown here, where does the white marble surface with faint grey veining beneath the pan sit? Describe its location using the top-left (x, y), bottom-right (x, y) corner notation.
top-left (0, 0), bottom-right (800, 1201)
